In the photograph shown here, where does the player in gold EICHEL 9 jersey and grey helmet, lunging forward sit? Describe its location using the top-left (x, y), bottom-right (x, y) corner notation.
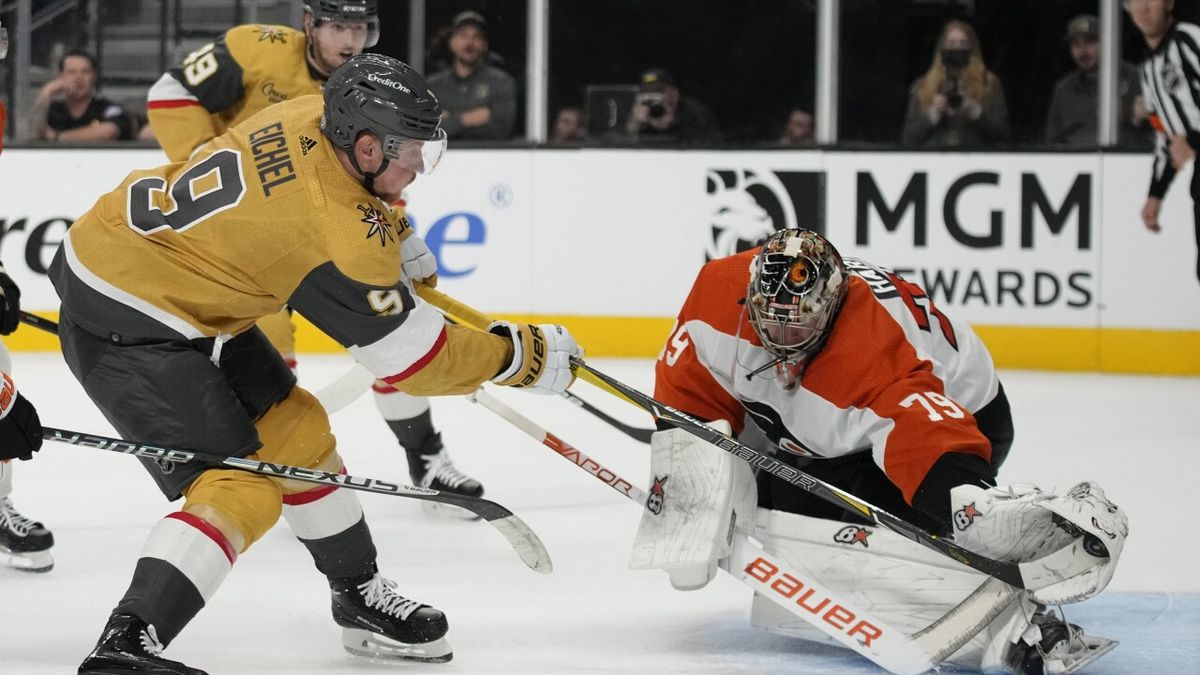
top-left (59, 54), bottom-right (581, 675)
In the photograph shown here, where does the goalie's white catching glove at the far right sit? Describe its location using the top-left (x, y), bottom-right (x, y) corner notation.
top-left (950, 482), bottom-right (1129, 604)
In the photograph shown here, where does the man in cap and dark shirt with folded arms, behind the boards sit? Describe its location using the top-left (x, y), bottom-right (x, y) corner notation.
top-left (428, 11), bottom-right (517, 141)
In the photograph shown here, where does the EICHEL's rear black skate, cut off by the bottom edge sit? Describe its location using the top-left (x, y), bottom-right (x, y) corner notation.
top-left (79, 614), bottom-right (208, 675)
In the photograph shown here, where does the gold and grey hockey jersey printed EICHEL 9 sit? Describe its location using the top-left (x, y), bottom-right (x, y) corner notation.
top-left (50, 96), bottom-right (512, 395)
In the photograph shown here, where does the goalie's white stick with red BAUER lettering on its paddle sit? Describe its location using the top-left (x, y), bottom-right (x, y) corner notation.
top-left (470, 387), bottom-right (1019, 674)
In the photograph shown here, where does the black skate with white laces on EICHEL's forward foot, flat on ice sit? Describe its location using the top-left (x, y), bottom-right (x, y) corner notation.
top-left (329, 574), bottom-right (454, 663)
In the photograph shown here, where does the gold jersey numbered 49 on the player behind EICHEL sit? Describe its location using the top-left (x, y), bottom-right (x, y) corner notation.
top-left (146, 25), bottom-right (325, 162)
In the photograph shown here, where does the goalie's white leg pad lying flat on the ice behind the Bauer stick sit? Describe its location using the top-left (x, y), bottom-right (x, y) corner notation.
top-left (750, 509), bottom-right (1056, 670)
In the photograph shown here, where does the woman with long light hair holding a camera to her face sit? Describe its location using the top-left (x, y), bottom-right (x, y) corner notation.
top-left (902, 19), bottom-right (1010, 148)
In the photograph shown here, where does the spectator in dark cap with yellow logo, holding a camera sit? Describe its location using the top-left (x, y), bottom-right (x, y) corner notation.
top-left (629, 68), bottom-right (721, 145)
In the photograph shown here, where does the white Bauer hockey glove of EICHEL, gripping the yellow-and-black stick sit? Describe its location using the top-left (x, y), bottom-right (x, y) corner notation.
top-left (487, 321), bottom-right (583, 394)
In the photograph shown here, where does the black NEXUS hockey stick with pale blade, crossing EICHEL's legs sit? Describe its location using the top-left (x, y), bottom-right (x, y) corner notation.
top-left (42, 426), bottom-right (553, 574)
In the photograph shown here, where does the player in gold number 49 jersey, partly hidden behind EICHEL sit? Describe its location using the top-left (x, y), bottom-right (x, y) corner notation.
top-left (146, 0), bottom-right (484, 504)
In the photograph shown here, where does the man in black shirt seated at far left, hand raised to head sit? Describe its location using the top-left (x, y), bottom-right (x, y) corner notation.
top-left (30, 49), bottom-right (133, 143)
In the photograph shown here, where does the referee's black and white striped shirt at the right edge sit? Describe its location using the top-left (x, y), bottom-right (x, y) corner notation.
top-left (1141, 22), bottom-right (1200, 197)
